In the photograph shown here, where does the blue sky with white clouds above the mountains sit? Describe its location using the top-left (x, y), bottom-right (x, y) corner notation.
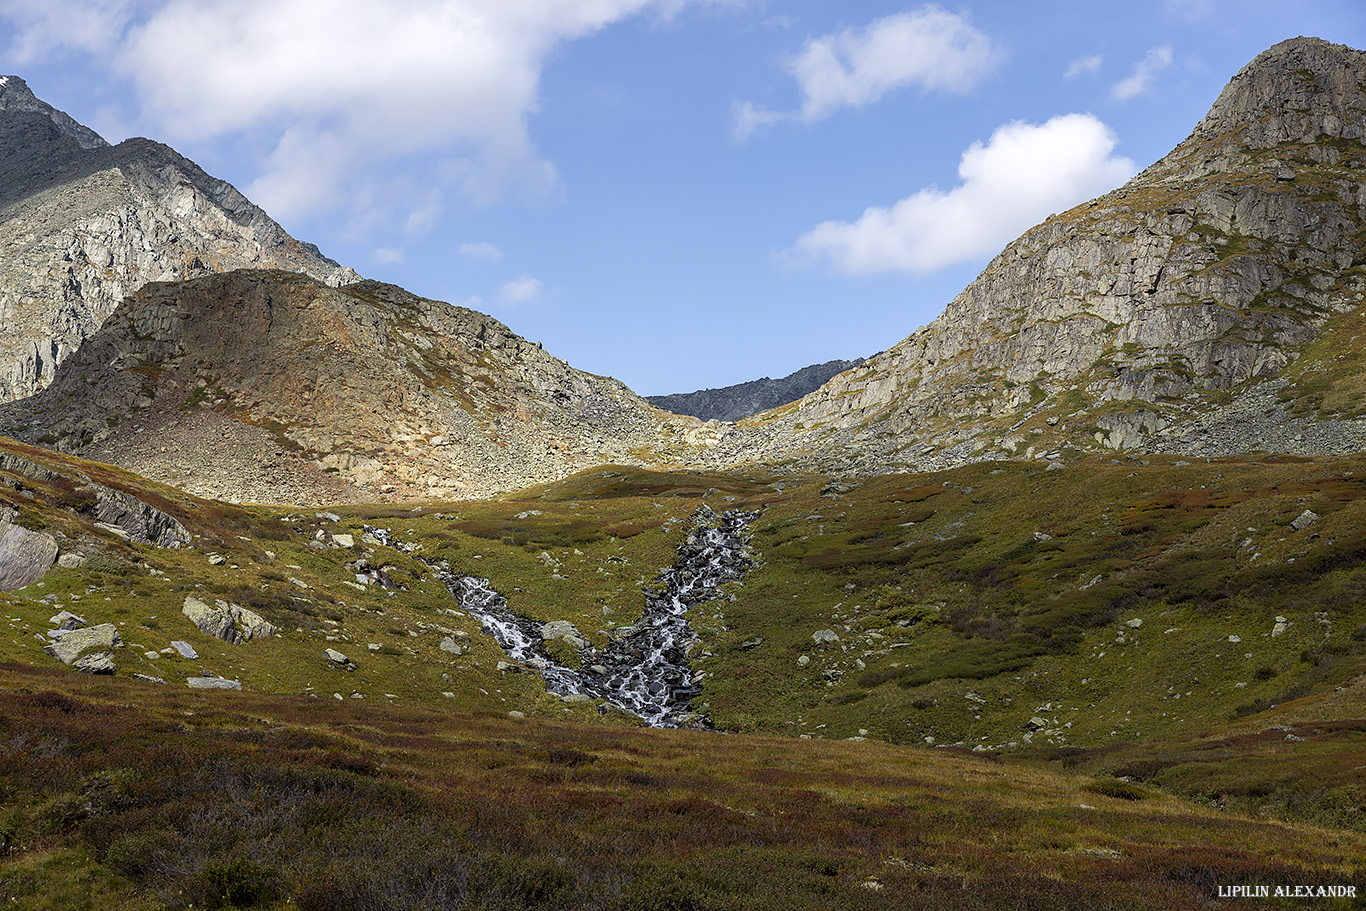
top-left (0, 0), bottom-right (1366, 395)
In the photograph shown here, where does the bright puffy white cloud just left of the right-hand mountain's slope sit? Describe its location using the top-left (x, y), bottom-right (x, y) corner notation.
top-left (781, 113), bottom-right (1137, 275)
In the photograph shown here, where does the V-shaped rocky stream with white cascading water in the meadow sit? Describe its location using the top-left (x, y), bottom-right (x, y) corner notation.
top-left (367, 505), bottom-right (758, 728)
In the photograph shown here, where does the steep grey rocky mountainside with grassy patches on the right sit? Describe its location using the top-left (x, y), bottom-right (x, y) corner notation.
top-left (716, 38), bottom-right (1366, 467)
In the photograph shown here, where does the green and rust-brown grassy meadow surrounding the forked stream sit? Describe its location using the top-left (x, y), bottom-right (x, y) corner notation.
top-left (0, 444), bottom-right (1366, 908)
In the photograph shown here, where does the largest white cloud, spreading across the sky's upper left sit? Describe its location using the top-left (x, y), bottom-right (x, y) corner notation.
top-left (0, 0), bottom-right (699, 226)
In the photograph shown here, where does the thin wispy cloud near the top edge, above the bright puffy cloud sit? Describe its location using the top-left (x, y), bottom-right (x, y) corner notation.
top-left (732, 5), bottom-right (1000, 139)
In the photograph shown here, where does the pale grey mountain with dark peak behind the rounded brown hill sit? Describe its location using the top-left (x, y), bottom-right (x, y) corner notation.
top-left (0, 76), bottom-right (359, 402)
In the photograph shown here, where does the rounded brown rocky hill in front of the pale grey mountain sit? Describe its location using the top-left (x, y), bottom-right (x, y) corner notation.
top-left (0, 270), bottom-right (712, 504)
